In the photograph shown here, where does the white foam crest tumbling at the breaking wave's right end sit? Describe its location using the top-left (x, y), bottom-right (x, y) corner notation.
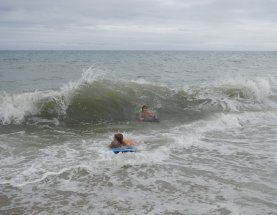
top-left (184, 77), bottom-right (277, 112)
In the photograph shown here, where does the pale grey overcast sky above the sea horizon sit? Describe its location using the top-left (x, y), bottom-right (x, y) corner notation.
top-left (0, 0), bottom-right (277, 50)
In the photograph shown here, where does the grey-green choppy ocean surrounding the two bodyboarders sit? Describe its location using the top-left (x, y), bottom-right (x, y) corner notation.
top-left (0, 51), bottom-right (277, 215)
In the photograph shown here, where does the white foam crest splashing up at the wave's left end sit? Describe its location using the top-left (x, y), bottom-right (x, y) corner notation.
top-left (0, 67), bottom-right (104, 124)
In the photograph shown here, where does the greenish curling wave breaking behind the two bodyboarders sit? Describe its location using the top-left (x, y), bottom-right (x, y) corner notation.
top-left (0, 68), bottom-right (277, 125)
